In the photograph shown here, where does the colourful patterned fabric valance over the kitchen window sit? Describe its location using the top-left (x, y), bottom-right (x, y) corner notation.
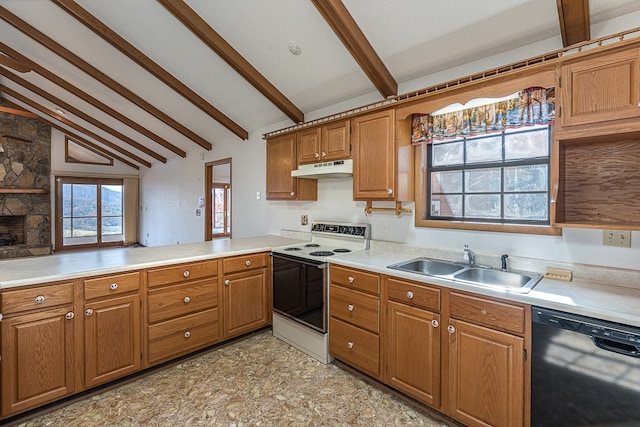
top-left (411, 87), bottom-right (556, 145)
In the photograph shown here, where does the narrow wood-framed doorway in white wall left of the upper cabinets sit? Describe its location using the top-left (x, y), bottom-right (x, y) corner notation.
top-left (205, 158), bottom-right (231, 241)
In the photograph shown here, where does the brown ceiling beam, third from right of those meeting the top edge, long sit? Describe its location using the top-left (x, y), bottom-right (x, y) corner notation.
top-left (51, 0), bottom-right (249, 139)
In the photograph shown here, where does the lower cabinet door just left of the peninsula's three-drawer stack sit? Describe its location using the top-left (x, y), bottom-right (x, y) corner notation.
top-left (84, 295), bottom-right (141, 387)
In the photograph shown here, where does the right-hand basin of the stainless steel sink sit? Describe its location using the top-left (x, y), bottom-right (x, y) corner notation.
top-left (453, 267), bottom-right (542, 293)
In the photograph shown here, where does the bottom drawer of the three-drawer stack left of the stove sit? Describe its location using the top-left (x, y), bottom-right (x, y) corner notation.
top-left (149, 308), bottom-right (220, 363)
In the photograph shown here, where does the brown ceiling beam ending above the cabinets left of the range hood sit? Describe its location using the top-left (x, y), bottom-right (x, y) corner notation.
top-left (158, 0), bottom-right (304, 123)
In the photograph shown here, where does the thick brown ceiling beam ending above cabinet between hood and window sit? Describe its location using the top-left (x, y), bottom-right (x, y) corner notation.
top-left (311, 0), bottom-right (398, 98)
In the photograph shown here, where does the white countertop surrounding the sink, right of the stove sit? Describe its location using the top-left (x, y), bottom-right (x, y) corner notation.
top-left (328, 246), bottom-right (640, 327)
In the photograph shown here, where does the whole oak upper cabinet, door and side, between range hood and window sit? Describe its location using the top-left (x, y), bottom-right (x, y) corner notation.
top-left (351, 109), bottom-right (414, 201)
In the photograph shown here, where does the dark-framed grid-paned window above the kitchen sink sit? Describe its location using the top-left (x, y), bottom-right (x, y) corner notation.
top-left (417, 125), bottom-right (555, 234)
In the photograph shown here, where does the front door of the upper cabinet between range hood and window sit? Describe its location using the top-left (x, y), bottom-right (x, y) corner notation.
top-left (351, 110), bottom-right (396, 200)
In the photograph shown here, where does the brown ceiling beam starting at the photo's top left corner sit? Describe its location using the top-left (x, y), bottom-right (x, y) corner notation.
top-left (0, 6), bottom-right (212, 150)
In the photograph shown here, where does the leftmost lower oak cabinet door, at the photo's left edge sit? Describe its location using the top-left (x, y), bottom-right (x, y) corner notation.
top-left (1, 306), bottom-right (75, 416)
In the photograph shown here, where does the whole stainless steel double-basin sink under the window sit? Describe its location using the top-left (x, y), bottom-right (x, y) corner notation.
top-left (388, 257), bottom-right (542, 293)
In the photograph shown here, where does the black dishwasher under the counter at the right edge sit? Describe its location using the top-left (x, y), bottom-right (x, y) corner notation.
top-left (531, 307), bottom-right (640, 427)
